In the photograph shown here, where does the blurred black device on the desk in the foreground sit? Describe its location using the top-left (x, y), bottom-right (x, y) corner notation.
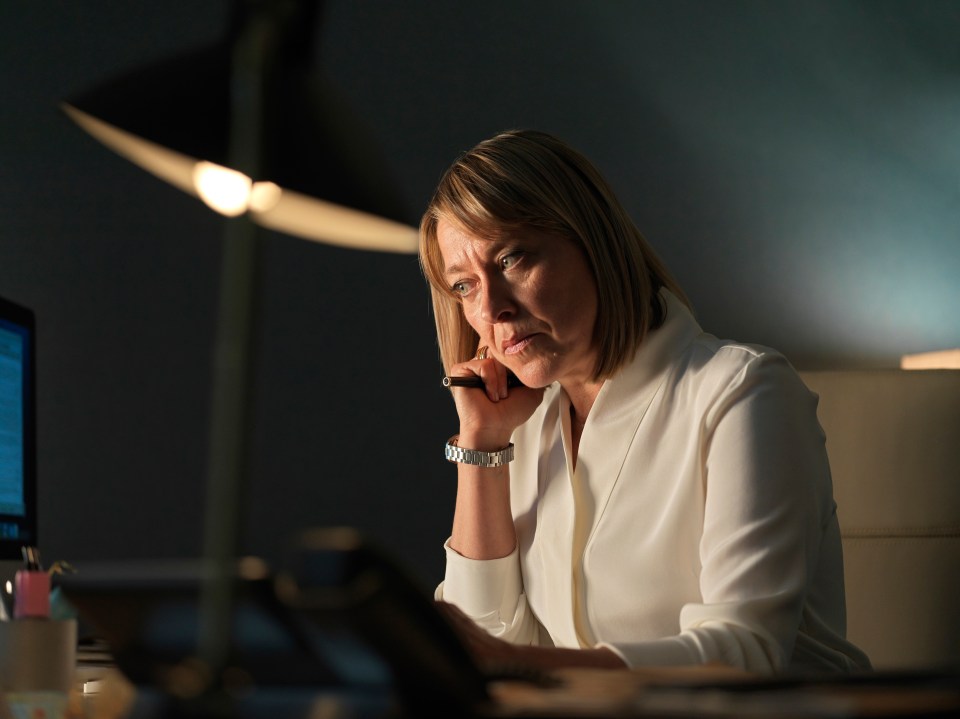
top-left (60, 529), bottom-right (487, 719)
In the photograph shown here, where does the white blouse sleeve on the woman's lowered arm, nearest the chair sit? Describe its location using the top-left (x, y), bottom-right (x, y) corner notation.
top-left (605, 354), bottom-right (864, 673)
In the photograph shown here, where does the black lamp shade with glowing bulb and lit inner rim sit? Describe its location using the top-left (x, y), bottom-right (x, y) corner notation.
top-left (62, 3), bottom-right (417, 252)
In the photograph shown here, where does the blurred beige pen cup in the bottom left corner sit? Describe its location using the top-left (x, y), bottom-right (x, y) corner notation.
top-left (0, 619), bottom-right (77, 719)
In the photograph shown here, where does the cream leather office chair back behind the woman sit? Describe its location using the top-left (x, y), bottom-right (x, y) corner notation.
top-left (801, 370), bottom-right (960, 669)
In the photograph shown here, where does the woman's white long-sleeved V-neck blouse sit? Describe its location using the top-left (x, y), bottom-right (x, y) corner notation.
top-left (436, 292), bottom-right (869, 672)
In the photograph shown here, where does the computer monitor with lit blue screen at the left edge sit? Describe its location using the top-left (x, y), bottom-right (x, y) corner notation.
top-left (0, 298), bottom-right (37, 560)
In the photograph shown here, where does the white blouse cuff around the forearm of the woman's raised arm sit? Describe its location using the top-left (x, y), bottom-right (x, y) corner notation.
top-left (434, 539), bottom-right (539, 644)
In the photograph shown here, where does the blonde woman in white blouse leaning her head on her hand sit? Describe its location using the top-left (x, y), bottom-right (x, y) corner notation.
top-left (420, 131), bottom-right (868, 672)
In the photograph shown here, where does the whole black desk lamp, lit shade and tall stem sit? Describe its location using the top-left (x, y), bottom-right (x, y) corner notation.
top-left (62, 0), bottom-right (417, 708)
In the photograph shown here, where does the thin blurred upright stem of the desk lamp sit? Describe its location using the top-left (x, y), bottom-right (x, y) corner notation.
top-left (199, 4), bottom-right (276, 695)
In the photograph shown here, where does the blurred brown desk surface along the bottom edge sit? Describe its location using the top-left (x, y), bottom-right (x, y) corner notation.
top-left (75, 667), bottom-right (960, 719)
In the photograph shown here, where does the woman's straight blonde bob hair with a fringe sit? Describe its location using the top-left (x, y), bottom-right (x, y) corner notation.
top-left (420, 130), bottom-right (689, 380)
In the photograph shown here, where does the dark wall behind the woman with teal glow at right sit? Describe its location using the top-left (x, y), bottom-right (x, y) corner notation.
top-left (0, 0), bottom-right (960, 584)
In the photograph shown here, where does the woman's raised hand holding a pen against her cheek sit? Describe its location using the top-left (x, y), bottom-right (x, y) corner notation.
top-left (450, 357), bottom-right (543, 451)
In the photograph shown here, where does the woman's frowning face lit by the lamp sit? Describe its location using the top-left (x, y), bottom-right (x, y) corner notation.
top-left (437, 219), bottom-right (597, 387)
